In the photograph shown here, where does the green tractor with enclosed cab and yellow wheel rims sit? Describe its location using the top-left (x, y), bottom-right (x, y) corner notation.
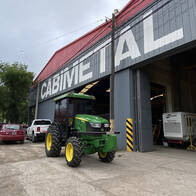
top-left (45, 93), bottom-right (117, 167)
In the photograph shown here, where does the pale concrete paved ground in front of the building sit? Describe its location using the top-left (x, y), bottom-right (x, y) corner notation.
top-left (0, 142), bottom-right (196, 196)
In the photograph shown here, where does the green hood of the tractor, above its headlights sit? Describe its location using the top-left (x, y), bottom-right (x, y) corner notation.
top-left (75, 114), bottom-right (109, 123)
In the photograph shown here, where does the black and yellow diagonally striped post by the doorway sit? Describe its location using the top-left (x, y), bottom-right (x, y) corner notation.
top-left (126, 118), bottom-right (134, 152)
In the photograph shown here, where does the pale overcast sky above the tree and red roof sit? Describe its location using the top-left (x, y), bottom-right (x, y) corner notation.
top-left (0, 0), bottom-right (130, 76)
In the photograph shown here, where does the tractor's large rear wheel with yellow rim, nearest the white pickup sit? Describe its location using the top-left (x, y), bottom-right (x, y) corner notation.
top-left (45, 122), bottom-right (61, 157)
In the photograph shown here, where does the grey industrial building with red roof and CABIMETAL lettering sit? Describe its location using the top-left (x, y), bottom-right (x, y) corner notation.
top-left (29, 0), bottom-right (196, 152)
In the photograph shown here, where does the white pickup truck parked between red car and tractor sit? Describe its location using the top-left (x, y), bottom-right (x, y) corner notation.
top-left (27, 119), bottom-right (52, 142)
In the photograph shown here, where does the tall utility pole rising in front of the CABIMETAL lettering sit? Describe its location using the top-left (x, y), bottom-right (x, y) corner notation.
top-left (110, 13), bottom-right (116, 133)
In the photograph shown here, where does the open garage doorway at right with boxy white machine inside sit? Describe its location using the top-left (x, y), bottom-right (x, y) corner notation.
top-left (142, 48), bottom-right (196, 149)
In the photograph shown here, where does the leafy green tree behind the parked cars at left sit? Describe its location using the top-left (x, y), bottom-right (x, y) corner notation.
top-left (0, 63), bottom-right (33, 123)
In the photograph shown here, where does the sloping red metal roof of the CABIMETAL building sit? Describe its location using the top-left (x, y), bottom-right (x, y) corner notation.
top-left (35, 0), bottom-right (154, 81)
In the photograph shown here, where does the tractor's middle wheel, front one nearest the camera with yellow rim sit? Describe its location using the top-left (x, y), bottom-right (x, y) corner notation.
top-left (65, 137), bottom-right (82, 167)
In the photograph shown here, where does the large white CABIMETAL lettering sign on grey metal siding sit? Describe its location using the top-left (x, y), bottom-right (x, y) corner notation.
top-left (40, 1), bottom-right (194, 104)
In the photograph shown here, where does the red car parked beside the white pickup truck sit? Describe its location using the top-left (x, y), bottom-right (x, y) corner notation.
top-left (0, 124), bottom-right (24, 143)
